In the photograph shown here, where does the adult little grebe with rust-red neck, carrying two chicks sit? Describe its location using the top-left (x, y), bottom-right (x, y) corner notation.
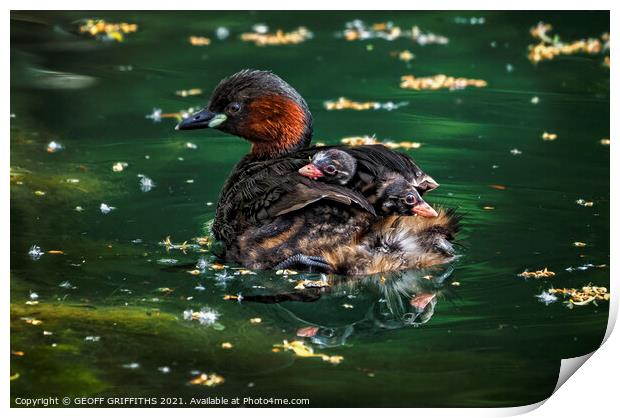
top-left (177, 70), bottom-right (456, 274)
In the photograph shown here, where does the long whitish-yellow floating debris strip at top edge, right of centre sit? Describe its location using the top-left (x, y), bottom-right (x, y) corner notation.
top-left (342, 19), bottom-right (449, 45)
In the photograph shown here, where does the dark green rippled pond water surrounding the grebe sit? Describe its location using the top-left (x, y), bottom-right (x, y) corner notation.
top-left (10, 12), bottom-right (609, 406)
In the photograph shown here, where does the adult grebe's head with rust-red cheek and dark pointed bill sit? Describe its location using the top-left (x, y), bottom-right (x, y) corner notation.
top-left (177, 70), bottom-right (312, 156)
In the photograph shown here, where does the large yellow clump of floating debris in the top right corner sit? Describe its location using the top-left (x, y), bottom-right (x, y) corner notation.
top-left (528, 22), bottom-right (609, 64)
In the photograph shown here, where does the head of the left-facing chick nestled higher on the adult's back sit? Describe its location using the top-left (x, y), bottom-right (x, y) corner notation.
top-left (299, 149), bottom-right (357, 186)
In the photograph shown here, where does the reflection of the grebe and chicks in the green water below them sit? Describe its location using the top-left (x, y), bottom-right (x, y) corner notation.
top-left (220, 263), bottom-right (454, 347)
